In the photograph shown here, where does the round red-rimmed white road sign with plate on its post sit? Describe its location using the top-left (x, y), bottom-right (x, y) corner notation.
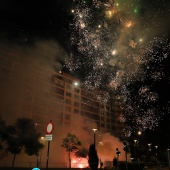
top-left (45, 120), bottom-right (54, 170)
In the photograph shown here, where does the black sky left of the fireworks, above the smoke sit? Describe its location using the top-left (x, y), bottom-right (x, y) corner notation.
top-left (0, 0), bottom-right (71, 48)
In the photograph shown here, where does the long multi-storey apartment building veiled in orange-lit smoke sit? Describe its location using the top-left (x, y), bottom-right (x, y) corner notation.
top-left (0, 45), bottom-right (125, 167)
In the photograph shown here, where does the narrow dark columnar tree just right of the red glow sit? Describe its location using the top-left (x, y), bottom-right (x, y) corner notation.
top-left (88, 144), bottom-right (99, 170)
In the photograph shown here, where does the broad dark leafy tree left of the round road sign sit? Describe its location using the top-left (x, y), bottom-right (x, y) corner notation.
top-left (5, 118), bottom-right (44, 167)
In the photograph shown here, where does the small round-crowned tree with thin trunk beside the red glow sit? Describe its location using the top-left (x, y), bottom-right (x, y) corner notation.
top-left (61, 133), bottom-right (81, 168)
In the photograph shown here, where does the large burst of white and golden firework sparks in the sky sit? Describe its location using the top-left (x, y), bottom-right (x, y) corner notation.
top-left (66, 0), bottom-right (170, 133)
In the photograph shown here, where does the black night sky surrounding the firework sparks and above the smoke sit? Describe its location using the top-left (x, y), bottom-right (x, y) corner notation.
top-left (0, 0), bottom-right (170, 146)
